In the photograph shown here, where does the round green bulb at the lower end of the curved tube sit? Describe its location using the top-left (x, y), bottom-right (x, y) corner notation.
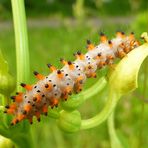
top-left (58, 110), bottom-right (81, 133)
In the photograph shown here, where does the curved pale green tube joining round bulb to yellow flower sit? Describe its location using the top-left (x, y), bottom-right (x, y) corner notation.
top-left (81, 91), bottom-right (121, 129)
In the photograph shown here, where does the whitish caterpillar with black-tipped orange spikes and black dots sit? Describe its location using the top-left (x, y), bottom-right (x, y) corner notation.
top-left (4, 31), bottom-right (140, 125)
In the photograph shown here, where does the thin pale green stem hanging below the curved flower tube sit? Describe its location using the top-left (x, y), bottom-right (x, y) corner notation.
top-left (107, 112), bottom-right (123, 148)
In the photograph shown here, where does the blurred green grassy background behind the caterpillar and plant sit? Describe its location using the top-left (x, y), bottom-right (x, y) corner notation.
top-left (0, 0), bottom-right (148, 148)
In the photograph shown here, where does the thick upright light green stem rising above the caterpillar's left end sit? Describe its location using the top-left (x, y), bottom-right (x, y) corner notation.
top-left (11, 0), bottom-right (30, 91)
